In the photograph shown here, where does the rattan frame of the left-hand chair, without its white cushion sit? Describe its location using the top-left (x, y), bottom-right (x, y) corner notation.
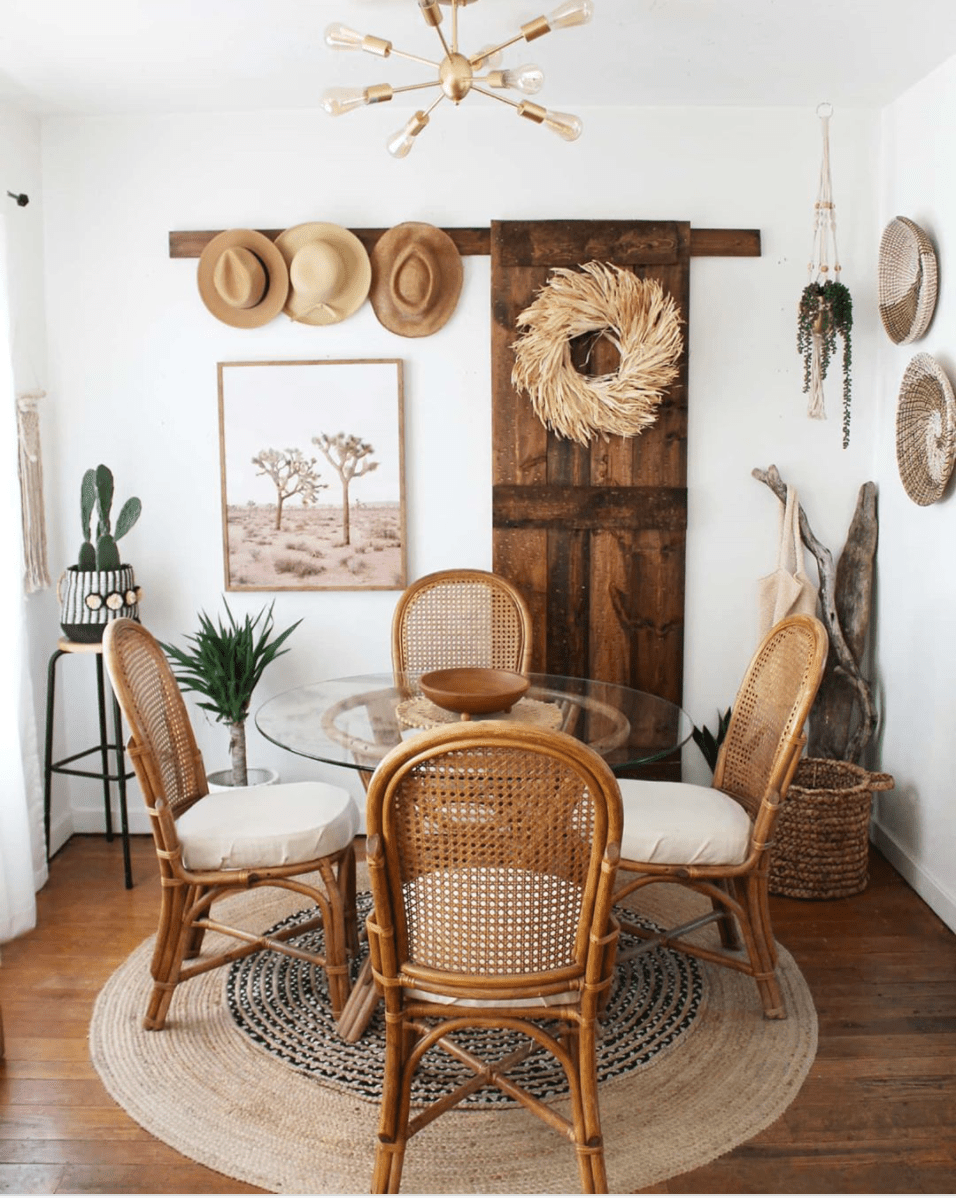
top-left (103, 618), bottom-right (357, 1030)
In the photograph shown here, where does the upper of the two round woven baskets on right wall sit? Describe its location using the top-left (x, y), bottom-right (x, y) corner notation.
top-left (877, 217), bottom-right (937, 345)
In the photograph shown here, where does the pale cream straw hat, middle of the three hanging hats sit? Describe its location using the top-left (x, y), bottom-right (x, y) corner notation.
top-left (276, 222), bottom-right (371, 325)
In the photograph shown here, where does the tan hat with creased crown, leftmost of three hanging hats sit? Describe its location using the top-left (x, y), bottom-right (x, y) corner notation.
top-left (196, 229), bottom-right (289, 328)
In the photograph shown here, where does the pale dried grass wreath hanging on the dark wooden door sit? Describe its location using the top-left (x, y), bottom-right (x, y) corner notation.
top-left (512, 262), bottom-right (684, 444)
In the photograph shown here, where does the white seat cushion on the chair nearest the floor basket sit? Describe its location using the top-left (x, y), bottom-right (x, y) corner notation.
top-left (621, 778), bottom-right (751, 865)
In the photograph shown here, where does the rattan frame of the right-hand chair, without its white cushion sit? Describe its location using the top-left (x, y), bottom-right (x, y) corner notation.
top-left (615, 616), bottom-right (828, 1018)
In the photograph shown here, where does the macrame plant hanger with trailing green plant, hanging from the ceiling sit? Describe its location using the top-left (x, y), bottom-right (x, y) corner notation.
top-left (797, 104), bottom-right (853, 449)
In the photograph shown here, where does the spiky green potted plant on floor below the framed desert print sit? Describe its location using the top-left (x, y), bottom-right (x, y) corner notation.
top-left (161, 599), bottom-right (302, 787)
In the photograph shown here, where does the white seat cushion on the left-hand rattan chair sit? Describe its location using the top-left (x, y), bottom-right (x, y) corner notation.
top-left (176, 782), bottom-right (358, 870)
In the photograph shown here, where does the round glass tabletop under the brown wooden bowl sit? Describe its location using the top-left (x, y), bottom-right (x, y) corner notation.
top-left (255, 671), bottom-right (694, 774)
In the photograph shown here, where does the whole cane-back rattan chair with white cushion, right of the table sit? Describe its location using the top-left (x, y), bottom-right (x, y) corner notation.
top-left (615, 616), bottom-right (827, 1018)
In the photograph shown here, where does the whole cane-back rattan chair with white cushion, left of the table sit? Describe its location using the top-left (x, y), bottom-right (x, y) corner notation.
top-left (103, 619), bottom-right (358, 1030)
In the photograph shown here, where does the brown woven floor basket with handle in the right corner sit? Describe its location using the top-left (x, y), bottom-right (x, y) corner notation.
top-left (770, 757), bottom-right (896, 899)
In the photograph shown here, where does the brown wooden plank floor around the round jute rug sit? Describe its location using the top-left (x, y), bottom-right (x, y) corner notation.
top-left (0, 836), bottom-right (956, 1194)
